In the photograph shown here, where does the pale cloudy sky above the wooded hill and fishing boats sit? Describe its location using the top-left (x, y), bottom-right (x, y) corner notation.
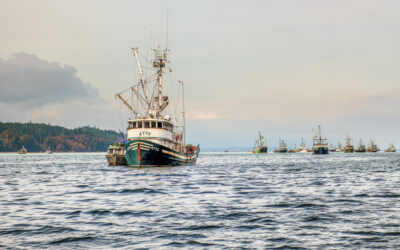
top-left (0, 0), bottom-right (400, 149)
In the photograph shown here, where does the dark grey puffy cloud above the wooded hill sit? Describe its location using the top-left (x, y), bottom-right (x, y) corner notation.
top-left (0, 53), bottom-right (101, 106)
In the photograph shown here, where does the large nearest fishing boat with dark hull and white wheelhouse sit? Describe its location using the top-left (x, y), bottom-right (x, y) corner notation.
top-left (115, 46), bottom-right (200, 167)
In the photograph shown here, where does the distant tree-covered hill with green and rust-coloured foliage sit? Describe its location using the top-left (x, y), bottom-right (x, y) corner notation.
top-left (0, 122), bottom-right (122, 152)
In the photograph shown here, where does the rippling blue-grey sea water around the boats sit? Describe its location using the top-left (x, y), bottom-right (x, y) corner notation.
top-left (0, 153), bottom-right (400, 249)
